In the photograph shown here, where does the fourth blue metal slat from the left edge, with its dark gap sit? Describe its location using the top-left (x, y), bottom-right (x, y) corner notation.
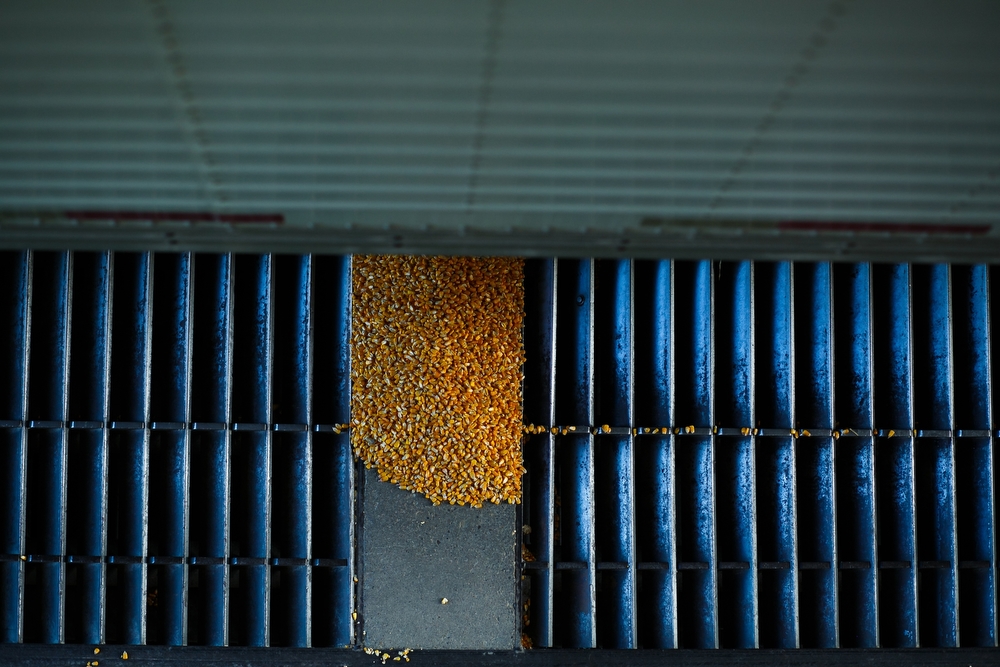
top-left (108, 253), bottom-right (153, 644)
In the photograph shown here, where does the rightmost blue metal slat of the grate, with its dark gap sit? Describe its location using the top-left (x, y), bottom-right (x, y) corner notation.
top-left (951, 265), bottom-right (997, 646)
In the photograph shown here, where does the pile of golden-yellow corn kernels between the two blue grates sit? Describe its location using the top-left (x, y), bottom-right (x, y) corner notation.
top-left (351, 255), bottom-right (524, 507)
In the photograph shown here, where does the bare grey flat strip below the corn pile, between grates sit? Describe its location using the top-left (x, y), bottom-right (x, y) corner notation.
top-left (359, 470), bottom-right (520, 650)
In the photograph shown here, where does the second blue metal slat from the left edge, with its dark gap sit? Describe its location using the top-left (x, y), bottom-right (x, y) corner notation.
top-left (25, 252), bottom-right (73, 644)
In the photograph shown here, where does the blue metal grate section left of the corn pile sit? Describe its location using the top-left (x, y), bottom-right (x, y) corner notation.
top-left (0, 252), bottom-right (354, 646)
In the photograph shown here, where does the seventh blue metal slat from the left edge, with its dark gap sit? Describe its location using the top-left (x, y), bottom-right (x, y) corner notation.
top-left (230, 255), bottom-right (273, 646)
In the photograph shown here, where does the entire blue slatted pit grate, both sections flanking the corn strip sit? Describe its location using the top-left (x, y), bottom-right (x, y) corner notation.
top-left (0, 252), bottom-right (1000, 655)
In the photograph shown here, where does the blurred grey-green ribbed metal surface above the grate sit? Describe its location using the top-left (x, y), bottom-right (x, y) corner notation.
top-left (0, 0), bottom-right (1000, 256)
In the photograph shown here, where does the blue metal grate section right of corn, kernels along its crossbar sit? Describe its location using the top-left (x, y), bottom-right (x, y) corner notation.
top-left (524, 259), bottom-right (1000, 648)
